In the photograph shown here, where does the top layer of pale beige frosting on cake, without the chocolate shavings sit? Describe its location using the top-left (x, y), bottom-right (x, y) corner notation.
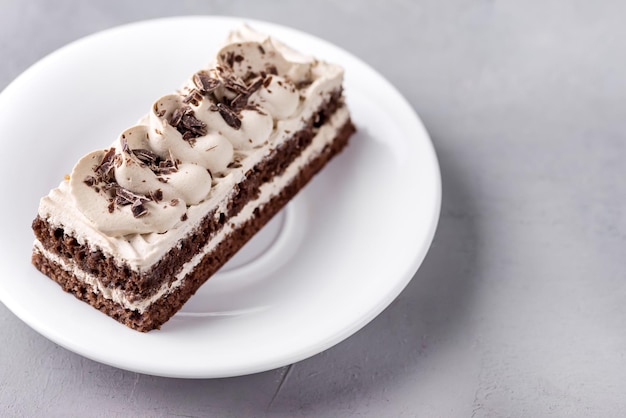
top-left (39, 27), bottom-right (343, 271)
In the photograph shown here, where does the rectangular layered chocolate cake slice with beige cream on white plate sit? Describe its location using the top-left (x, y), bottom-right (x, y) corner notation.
top-left (32, 26), bottom-right (355, 332)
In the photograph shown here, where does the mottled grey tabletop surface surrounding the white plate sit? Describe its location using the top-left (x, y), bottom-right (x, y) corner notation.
top-left (0, 0), bottom-right (626, 417)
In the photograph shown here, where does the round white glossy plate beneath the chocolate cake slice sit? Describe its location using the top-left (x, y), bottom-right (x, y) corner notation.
top-left (0, 17), bottom-right (441, 378)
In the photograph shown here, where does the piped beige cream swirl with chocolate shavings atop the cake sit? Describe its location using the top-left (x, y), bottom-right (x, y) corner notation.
top-left (70, 27), bottom-right (315, 236)
